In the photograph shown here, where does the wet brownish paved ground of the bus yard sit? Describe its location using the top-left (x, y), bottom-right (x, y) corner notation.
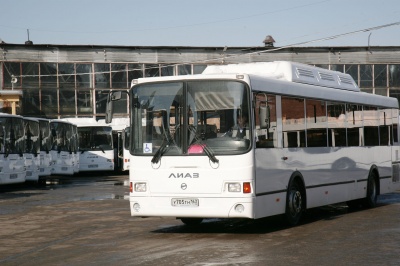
top-left (0, 175), bottom-right (400, 265)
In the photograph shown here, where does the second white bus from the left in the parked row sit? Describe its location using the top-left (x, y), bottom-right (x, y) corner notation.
top-left (24, 117), bottom-right (40, 182)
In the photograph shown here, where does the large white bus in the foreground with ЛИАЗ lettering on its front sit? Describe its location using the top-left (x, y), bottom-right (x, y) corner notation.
top-left (106, 61), bottom-right (400, 225)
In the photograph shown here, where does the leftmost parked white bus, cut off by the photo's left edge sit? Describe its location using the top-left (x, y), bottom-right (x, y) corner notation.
top-left (0, 113), bottom-right (26, 184)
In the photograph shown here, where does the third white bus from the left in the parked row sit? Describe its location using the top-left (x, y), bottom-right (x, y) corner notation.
top-left (37, 118), bottom-right (52, 177)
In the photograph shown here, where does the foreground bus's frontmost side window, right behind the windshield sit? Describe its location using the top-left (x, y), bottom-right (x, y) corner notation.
top-left (254, 93), bottom-right (278, 148)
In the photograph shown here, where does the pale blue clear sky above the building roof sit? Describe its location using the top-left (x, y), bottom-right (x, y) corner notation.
top-left (0, 0), bottom-right (400, 47)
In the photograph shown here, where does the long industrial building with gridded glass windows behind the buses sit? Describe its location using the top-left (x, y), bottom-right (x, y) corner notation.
top-left (0, 42), bottom-right (400, 119)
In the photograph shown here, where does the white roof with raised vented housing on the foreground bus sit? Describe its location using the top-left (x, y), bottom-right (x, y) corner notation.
top-left (132, 61), bottom-right (399, 108)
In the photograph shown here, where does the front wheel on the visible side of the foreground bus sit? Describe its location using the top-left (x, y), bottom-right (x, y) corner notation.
top-left (285, 178), bottom-right (305, 226)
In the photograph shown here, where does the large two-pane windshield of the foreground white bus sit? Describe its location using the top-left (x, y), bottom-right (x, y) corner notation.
top-left (131, 80), bottom-right (252, 159)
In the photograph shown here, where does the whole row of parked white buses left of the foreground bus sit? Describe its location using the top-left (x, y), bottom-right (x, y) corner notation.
top-left (0, 113), bottom-right (129, 184)
